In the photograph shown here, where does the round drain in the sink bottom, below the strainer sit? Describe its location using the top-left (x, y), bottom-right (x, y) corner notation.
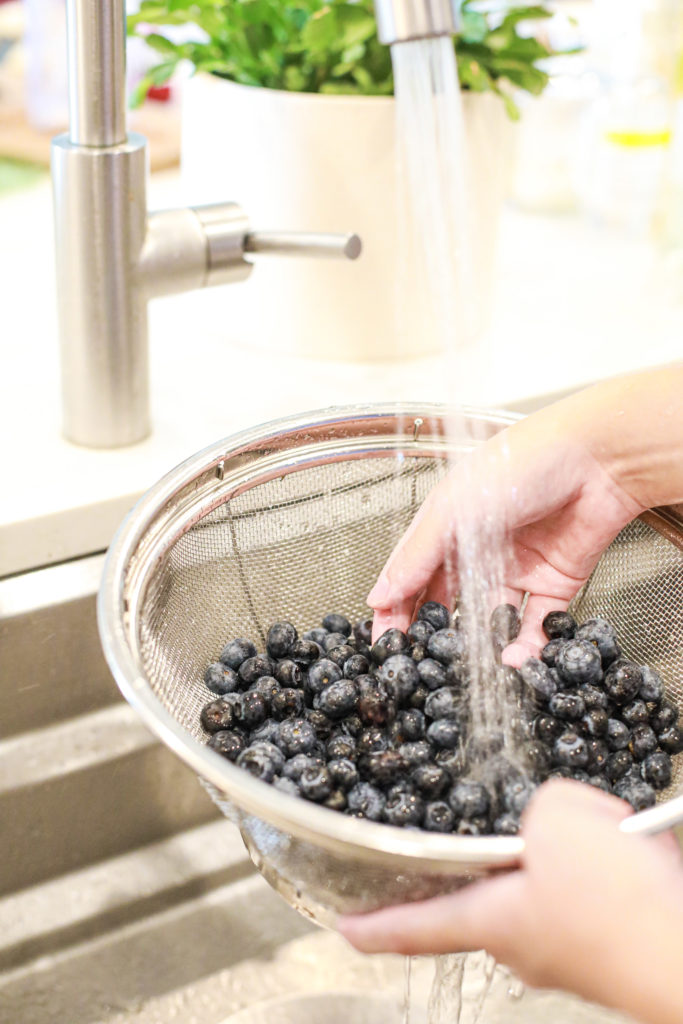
top-left (223, 992), bottom-right (411, 1024)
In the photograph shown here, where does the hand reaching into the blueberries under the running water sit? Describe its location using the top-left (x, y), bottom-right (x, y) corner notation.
top-left (368, 403), bottom-right (643, 666)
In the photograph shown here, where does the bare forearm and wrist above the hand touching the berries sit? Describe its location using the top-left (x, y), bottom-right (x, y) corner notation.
top-left (528, 365), bottom-right (683, 508)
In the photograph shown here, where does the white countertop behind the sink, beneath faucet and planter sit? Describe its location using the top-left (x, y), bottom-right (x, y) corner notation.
top-left (0, 173), bottom-right (683, 575)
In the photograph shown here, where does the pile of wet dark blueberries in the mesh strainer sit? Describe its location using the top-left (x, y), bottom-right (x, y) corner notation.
top-left (194, 601), bottom-right (683, 836)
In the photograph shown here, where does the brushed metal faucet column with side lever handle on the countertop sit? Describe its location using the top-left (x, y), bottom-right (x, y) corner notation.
top-left (52, 0), bottom-right (360, 447)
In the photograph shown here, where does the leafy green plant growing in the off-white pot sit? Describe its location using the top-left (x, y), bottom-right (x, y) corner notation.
top-left (128, 0), bottom-right (565, 118)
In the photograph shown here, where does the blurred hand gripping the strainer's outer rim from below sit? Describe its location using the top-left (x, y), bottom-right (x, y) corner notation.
top-left (339, 780), bottom-right (683, 1024)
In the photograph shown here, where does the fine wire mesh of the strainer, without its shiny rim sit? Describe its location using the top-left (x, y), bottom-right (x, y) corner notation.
top-left (132, 443), bottom-right (683, 923)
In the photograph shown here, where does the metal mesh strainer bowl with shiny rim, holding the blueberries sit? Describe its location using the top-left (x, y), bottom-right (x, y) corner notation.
top-left (98, 404), bottom-right (683, 923)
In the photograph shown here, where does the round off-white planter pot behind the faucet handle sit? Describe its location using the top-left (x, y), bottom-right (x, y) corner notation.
top-left (181, 75), bottom-right (512, 360)
